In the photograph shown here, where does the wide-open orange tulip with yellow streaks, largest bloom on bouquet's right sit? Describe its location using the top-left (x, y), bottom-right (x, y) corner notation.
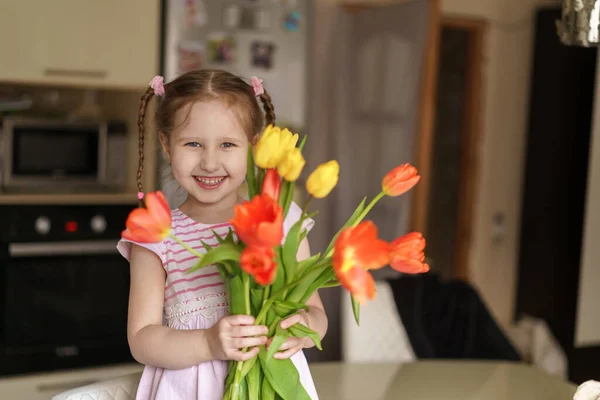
top-left (333, 221), bottom-right (390, 303)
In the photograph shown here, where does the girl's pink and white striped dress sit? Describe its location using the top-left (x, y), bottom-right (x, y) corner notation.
top-left (117, 203), bottom-right (318, 400)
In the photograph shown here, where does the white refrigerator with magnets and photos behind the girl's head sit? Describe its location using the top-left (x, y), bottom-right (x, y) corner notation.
top-left (160, 0), bottom-right (313, 207)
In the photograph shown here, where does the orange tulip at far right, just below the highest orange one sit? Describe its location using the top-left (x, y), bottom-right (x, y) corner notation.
top-left (390, 232), bottom-right (429, 274)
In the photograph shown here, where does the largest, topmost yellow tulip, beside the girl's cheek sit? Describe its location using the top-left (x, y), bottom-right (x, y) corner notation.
top-left (254, 125), bottom-right (298, 169)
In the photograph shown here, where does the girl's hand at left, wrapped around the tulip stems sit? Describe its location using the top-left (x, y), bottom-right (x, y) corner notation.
top-left (206, 315), bottom-right (268, 361)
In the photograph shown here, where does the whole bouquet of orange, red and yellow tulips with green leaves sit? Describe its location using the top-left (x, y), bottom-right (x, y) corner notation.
top-left (123, 126), bottom-right (429, 400)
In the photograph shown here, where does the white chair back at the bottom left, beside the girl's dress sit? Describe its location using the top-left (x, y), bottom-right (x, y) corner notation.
top-left (52, 372), bottom-right (141, 400)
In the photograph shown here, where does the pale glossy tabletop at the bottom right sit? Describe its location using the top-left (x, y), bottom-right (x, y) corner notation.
top-left (310, 361), bottom-right (577, 400)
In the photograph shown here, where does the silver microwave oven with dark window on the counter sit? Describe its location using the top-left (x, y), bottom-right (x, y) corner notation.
top-left (0, 117), bottom-right (127, 192)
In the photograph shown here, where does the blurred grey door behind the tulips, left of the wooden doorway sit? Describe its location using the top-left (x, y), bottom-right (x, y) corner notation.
top-left (304, 0), bottom-right (439, 361)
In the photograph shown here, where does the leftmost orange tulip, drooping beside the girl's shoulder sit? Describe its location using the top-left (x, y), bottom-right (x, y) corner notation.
top-left (121, 191), bottom-right (171, 243)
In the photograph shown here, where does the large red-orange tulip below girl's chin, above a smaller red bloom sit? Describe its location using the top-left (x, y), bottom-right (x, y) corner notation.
top-left (230, 194), bottom-right (283, 247)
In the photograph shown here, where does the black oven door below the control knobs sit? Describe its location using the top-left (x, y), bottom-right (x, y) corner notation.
top-left (0, 240), bottom-right (133, 375)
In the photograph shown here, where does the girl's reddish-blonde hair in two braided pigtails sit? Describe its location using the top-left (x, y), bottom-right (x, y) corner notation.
top-left (137, 69), bottom-right (275, 205)
